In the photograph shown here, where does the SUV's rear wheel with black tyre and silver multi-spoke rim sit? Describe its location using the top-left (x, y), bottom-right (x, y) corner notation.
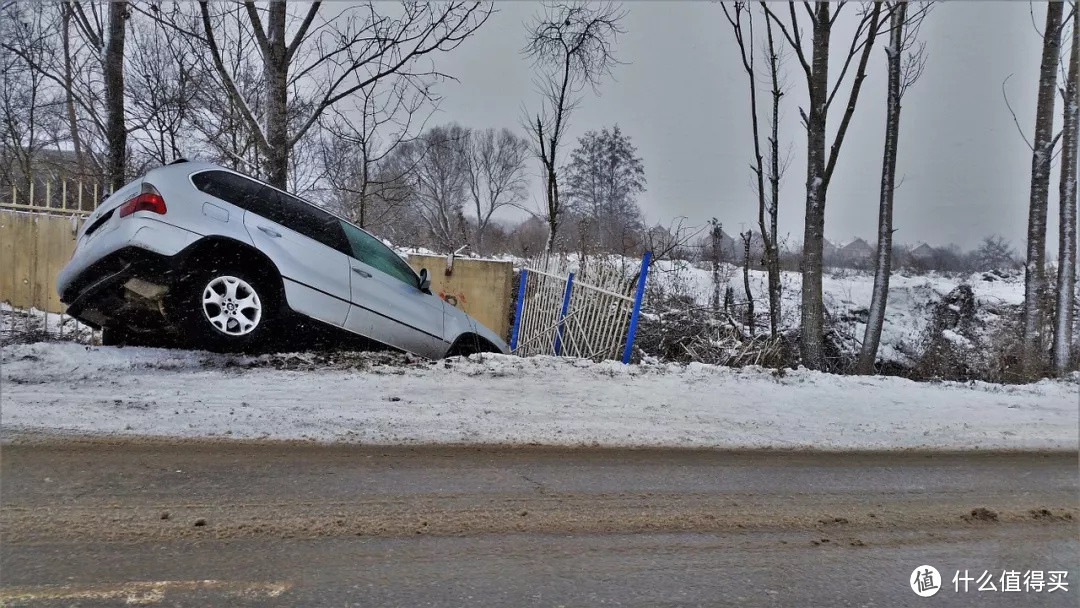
top-left (174, 266), bottom-right (280, 352)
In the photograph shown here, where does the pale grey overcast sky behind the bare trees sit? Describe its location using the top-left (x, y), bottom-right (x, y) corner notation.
top-left (432, 1), bottom-right (1061, 251)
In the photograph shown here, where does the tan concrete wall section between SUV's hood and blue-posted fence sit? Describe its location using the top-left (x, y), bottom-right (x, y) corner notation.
top-left (408, 255), bottom-right (514, 339)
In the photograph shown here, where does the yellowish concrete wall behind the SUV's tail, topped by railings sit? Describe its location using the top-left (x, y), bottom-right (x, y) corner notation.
top-left (0, 210), bottom-right (82, 312)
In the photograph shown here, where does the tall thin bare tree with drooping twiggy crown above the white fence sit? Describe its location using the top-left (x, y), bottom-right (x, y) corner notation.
top-left (524, 2), bottom-right (625, 249)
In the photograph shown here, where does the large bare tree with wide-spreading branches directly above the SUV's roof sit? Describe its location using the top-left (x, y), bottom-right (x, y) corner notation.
top-left (141, 1), bottom-right (491, 187)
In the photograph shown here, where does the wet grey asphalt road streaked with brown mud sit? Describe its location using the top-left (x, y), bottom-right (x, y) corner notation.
top-left (0, 442), bottom-right (1080, 607)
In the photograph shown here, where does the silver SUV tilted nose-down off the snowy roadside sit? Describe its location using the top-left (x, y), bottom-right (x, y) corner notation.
top-left (57, 161), bottom-right (507, 359)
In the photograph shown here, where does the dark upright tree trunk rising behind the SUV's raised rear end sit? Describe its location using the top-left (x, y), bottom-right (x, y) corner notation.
top-left (105, 2), bottom-right (127, 192)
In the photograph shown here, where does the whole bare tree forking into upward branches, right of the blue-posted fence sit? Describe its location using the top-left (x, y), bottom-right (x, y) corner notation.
top-left (762, 1), bottom-right (882, 369)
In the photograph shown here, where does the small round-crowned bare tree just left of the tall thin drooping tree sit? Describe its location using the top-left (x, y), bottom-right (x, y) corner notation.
top-left (463, 129), bottom-right (529, 255)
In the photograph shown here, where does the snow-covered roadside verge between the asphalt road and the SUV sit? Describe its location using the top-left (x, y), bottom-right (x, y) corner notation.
top-left (0, 343), bottom-right (1080, 450)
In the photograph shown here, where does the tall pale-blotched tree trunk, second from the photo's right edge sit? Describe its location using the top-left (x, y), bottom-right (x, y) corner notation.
top-left (1022, 2), bottom-right (1064, 379)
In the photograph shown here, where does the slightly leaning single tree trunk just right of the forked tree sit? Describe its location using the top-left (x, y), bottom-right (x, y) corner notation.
top-left (856, 2), bottom-right (907, 374)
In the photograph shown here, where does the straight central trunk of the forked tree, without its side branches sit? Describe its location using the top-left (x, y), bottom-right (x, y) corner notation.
top-left (800, 2), bottom-right (832, 369)
